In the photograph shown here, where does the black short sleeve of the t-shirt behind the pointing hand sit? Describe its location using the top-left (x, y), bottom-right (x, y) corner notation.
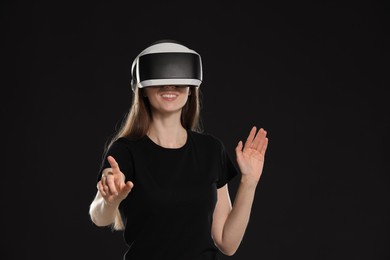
top-left (97, 138), bottom-right (134, 181)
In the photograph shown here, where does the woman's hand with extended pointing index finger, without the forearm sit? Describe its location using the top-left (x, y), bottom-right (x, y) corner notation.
top-left (97, 156), bottom-right (134, 205)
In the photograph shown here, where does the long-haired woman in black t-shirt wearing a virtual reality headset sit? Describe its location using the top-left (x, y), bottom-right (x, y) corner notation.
top-left (89, 41), bottom-right (268, 260)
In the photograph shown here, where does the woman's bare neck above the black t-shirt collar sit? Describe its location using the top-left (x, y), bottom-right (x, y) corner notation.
top-left (147, 115), bottom-right (187, 148)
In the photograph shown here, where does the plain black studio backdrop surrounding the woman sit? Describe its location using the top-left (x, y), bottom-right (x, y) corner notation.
top-left (0, 1), bottom-right (390, 260)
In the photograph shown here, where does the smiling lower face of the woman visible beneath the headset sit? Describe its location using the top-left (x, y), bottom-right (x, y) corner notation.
top-left (143, 86), bottom-right (190, 113)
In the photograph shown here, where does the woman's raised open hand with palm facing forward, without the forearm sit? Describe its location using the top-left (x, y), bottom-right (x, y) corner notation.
top-left (236, 126), bottom-right (268, 184)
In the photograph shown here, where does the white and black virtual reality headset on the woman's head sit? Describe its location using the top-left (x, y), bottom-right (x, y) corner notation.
top-left (131, 40), bottom-right (203, 91)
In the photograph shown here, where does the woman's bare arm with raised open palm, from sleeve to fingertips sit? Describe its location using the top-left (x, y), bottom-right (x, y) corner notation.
top-left (212, 127), bottom-right (268, 255)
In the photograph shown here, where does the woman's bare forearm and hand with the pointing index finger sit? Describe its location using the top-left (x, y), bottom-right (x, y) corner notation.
top-left (89, 156), bottom-right (134, 226)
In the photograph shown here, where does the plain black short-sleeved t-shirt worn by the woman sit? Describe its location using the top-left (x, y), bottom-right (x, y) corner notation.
top-left (99, 131), bottom-right (238, 260)
